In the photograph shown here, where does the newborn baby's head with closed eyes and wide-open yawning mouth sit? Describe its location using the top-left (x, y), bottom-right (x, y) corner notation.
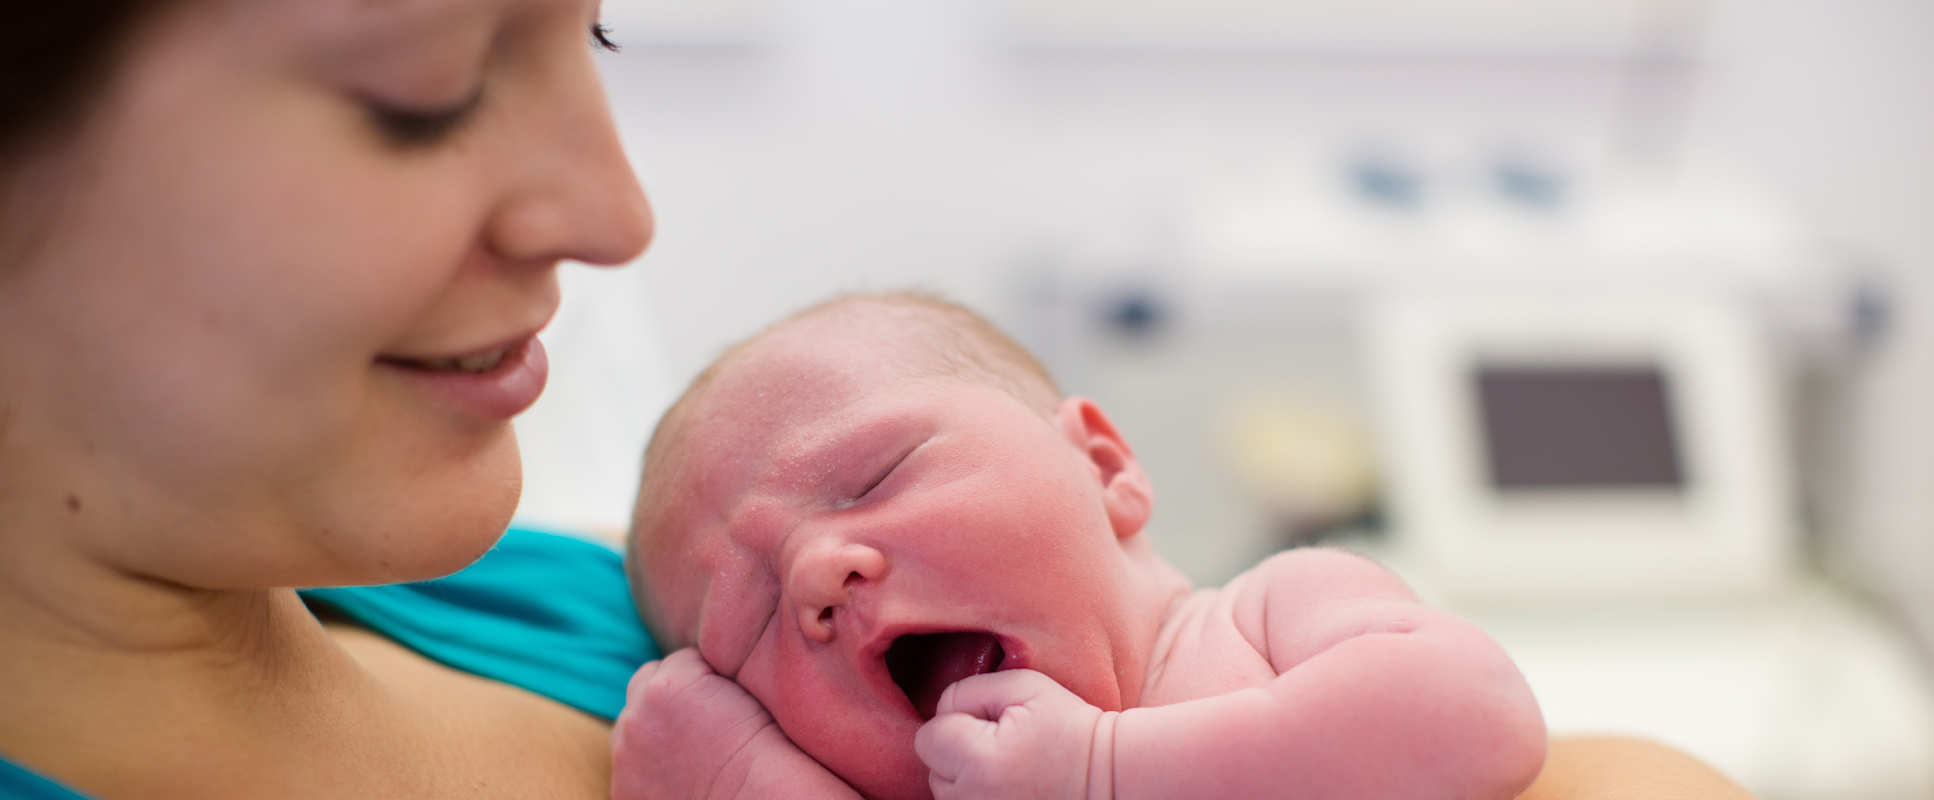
top-left (630, 294), bottom-right (1182, 796)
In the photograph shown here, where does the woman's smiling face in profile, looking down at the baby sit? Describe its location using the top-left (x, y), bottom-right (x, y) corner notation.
top-left (0, 0), bottom-right (652, 587)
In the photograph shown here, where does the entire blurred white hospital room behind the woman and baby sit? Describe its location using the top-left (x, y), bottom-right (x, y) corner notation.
top-left (518, 0), bottom-right (1934, 800)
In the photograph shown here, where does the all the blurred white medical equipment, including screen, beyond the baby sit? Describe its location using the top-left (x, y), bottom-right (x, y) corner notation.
top-left (1021, 149), bottom-right (1934, 800)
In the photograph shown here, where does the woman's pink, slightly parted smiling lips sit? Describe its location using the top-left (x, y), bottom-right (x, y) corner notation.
top-left (377, 336), bottom-right (551, 419)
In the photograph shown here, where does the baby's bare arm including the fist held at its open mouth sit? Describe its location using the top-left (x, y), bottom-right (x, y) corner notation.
top-left (915, 551), bottom-right (1545, 800)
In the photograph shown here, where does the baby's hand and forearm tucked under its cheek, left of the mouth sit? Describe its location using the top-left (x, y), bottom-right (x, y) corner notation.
top-left (611, 647), bottom-right (859, 800)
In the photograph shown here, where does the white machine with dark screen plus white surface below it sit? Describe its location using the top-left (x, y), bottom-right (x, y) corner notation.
top-left (1367, 290), bottom-right (1934, 798)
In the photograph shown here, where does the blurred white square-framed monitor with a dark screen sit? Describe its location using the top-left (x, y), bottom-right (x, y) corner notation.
top-left (1365, 286), bottom-right (1799, 601)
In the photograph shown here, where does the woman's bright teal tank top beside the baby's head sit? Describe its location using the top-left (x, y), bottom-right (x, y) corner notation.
top-left (0, 528), bottom-right (659, 800)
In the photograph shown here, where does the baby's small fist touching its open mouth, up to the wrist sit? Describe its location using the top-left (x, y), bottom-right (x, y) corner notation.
top-left (913, 669), bottom-right (1118, 800)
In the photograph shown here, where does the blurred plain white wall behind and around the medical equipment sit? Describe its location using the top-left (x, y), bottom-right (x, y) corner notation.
top-left (522, 0), bottom-right (1934, 640)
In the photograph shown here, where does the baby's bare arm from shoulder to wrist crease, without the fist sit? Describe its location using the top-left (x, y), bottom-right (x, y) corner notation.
top-left (1097, 549), bottom-right (1545, 798)
